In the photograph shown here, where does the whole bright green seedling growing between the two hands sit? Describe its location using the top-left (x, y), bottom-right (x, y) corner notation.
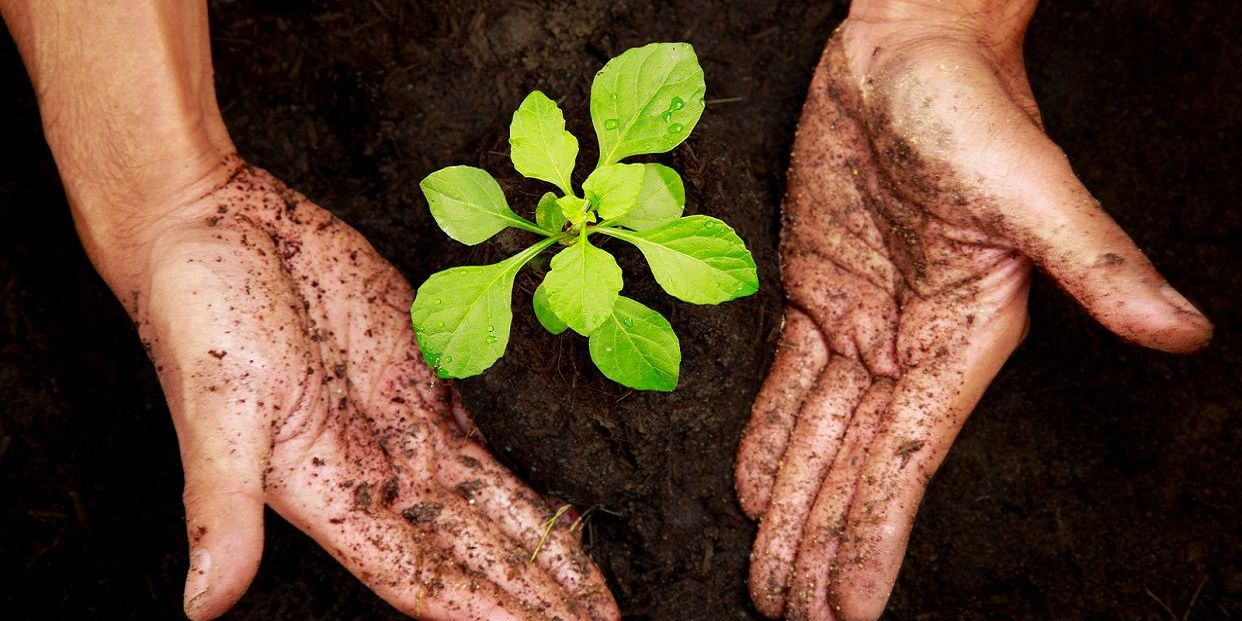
top-left (410, 43), bottom-right (759, 391)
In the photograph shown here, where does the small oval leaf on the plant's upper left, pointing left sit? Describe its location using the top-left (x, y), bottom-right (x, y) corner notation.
top-left (419, 166), bottom-right (540, 246)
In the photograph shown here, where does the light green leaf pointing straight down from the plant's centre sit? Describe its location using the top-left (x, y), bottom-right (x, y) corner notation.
top-left (543, 235), bottom-right (622, 337)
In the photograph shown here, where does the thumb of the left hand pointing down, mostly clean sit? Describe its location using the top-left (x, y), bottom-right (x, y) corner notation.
top-left (178, 389), bottom-right (266, 621)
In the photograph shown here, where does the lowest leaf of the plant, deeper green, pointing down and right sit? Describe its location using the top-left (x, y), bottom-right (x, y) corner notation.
top-left (590, 296), bottom-right (682, 392)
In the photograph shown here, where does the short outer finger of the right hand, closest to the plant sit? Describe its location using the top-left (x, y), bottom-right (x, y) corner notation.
top-left (734, 308), bottom-right (828, 519)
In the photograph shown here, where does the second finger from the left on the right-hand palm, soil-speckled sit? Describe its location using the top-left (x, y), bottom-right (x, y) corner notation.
top-left (750, 356), bottom-right (871, 619)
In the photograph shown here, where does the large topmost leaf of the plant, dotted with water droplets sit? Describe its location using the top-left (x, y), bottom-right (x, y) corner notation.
top-left (591, 43), bottom-right (707, 165)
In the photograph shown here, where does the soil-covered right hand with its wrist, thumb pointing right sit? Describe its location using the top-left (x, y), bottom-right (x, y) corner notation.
top-left (737, 0), bottom-right (1212, 621)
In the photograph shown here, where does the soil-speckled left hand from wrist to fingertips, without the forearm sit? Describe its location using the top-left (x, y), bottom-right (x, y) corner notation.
top-left (122, 158), bottom-right (619, 621)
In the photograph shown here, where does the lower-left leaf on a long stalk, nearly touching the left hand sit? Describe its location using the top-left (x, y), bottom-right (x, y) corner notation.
top-left (410, 238), bottom-right (555, 378)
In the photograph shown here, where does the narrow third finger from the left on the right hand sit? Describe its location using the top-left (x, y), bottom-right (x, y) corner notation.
top-left (787, 379), bottom-right (893, 621)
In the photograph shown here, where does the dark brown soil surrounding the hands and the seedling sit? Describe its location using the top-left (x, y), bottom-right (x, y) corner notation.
top-left (0, 0), bottom-right (1242, 621)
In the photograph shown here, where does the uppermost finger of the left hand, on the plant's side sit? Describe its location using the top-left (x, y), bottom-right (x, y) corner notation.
top-left (436, 441), bottom-right (621, 620)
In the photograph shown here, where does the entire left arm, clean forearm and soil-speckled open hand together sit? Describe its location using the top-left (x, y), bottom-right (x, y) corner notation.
top-left (0, 0), bottom-right (620, 621)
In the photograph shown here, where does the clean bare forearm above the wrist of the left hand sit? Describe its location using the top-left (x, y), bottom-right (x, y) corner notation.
top-left (0, 0), bottom-right (232, 279)
